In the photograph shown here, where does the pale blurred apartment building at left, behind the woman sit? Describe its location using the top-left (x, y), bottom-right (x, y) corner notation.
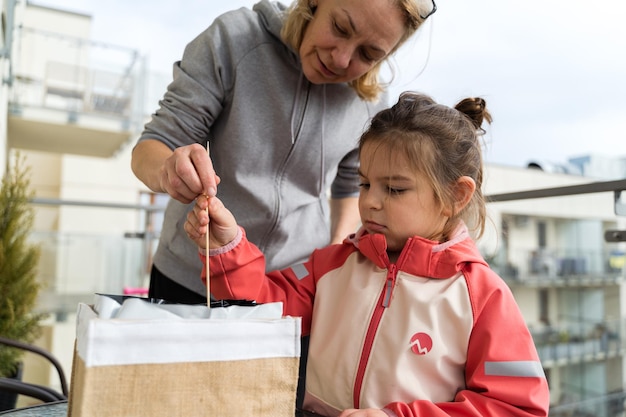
top-left (0, 0), bottom-right (156, 400)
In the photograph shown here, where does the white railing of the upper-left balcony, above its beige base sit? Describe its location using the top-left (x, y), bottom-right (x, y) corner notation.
top-left (10, 28), bottom-right (144, 123)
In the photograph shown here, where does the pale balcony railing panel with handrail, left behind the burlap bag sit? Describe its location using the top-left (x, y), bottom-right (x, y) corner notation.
top-left (30, 198), bottom-right (165, 321)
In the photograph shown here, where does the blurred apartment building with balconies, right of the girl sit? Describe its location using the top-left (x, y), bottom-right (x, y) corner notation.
top-left (482, 166), bottom-right (626, 416)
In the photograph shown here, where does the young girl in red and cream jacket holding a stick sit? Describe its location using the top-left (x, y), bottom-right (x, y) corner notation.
top-left (185, 93), bottom-right (549, 417)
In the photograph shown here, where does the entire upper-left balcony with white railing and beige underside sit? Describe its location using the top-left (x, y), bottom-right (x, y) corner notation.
top-left (7, 29), bottom-right (146, 158)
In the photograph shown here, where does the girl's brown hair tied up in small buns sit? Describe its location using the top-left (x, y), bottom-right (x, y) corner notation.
top-left (359, 92), bottom-right (491, 240)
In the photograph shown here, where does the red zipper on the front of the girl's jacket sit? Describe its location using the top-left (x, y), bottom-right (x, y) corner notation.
top-left (352, 264), bottom-right (398, 409)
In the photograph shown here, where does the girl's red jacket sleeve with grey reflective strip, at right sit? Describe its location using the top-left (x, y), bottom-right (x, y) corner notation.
top-left (386, 267), bottom-right (550, 417)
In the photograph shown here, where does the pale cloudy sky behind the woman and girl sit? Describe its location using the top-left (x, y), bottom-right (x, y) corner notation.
top-left (31, 0), bottom-right (626, 167)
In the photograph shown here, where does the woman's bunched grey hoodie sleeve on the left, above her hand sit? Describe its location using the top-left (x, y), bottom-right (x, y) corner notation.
top-left (139, 9), bottom-right (262, 149)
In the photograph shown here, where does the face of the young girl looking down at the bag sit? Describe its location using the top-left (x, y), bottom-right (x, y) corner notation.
top-left (359, 142), bottom-right (449, 252)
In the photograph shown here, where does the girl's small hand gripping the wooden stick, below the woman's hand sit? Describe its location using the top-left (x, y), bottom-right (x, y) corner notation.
top-left (184, 195), bottom-right (239, 249)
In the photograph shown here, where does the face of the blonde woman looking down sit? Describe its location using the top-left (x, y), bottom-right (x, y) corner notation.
top-left (300, 0), bottom-right (405, 84)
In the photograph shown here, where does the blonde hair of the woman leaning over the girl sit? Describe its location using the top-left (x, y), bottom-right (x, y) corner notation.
top-left (281, 0), bottom-right (424, 101)
